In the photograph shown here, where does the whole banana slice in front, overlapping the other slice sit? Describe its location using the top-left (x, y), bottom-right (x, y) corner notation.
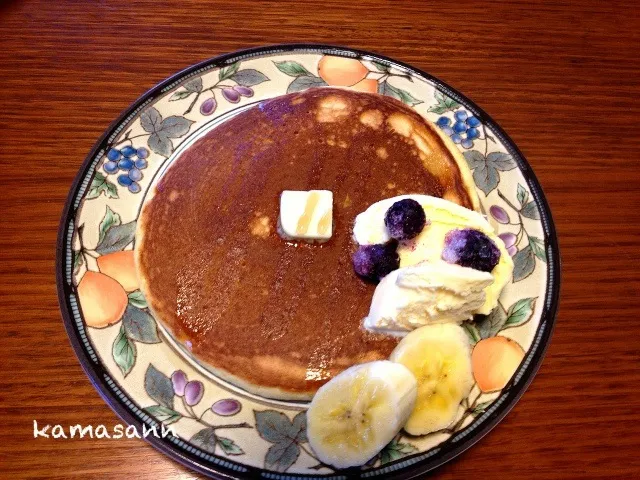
top-left (307, 360), bottom-right (417, 468)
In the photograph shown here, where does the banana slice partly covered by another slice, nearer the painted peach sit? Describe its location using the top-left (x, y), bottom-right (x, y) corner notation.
top-left (390, 323), bottom-right (473, 435)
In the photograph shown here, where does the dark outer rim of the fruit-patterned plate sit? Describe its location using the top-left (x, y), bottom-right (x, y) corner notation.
top-left (55, 43), bottom-right (561, 479)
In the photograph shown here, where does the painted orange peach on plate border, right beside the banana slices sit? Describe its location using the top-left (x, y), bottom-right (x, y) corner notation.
top-left (471, 337), bottom-right (524, 393)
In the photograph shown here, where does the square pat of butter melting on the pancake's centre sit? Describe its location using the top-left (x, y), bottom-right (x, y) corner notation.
top-left (278, 190), bottom-right (333, 242)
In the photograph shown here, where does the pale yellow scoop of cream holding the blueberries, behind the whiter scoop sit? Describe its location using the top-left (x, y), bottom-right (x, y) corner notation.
top-left (353, 194), bottom-right (513, 315)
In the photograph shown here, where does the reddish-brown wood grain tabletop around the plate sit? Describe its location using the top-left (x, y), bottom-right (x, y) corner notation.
top-left (0, 0), bottom-right (640, 480)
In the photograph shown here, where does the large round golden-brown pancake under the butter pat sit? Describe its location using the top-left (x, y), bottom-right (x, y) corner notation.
top-left (136, 88), bottom-right (478, 399)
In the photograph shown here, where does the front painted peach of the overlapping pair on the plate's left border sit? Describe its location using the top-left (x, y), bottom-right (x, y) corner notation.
top-left (78, 271), bottom-right (128, 328)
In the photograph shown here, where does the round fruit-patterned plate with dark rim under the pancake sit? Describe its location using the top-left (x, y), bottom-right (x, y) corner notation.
top-left (57, 45), bottom-right (559, 480)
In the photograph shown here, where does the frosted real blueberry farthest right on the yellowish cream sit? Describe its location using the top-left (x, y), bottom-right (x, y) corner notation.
top-left (442, 228), bottom-right (500, 272)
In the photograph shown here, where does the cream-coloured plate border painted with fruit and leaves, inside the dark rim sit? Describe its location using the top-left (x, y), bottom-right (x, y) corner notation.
top-left (67, 52), bottom-right (547, 478)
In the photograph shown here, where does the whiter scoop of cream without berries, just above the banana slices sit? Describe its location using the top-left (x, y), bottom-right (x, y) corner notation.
top-left (364, 260), bottom-right (494, 334)
